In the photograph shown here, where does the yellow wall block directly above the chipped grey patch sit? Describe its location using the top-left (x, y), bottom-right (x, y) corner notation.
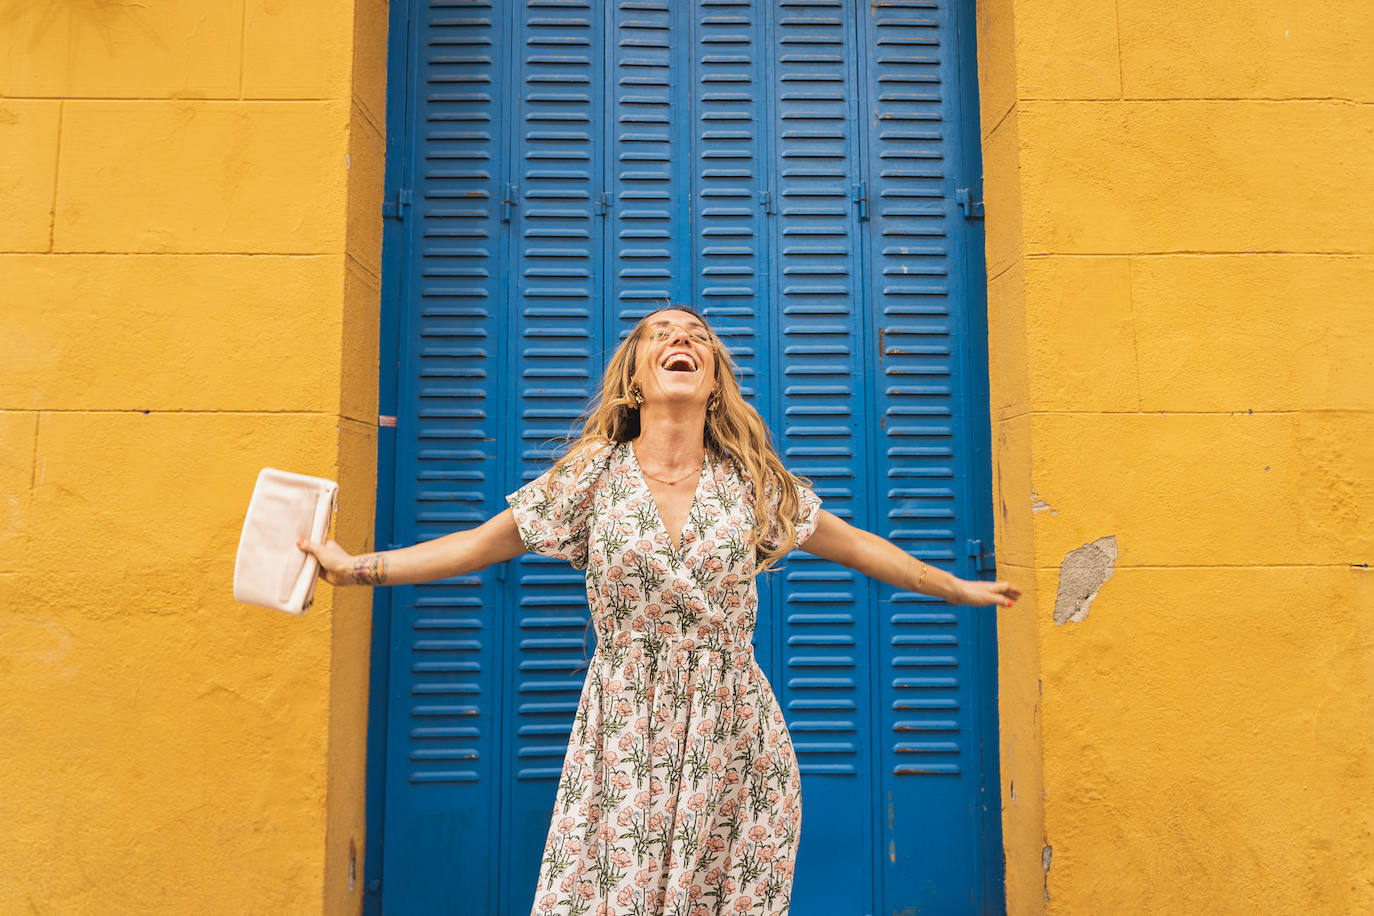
top-left (1031, 411), bottom-right (1374, 569)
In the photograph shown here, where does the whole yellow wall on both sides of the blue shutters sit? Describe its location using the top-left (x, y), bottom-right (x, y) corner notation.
top-left (0, 0), bottom-right (1374, 915)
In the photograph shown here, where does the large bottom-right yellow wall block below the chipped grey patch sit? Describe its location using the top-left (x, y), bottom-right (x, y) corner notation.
top-left (1036, 563), bottom-right (1374, 915)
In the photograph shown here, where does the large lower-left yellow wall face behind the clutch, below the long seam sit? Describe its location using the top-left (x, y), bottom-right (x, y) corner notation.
top-left (0, 412), bottom-right (348, 913)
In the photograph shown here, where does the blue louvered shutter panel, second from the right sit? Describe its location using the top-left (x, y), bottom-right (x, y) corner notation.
top-left (769, 0), bottom-right (874, 916)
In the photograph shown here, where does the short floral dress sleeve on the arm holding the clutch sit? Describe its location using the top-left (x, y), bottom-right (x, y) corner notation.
top-left (506, 452), bottom-right (606, 570)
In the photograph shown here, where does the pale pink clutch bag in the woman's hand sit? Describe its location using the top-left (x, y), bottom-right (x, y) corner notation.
top-left (234, 467), bottom-right (339, 614)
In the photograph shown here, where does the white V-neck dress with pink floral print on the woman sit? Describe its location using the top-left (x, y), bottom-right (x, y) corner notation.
top-left (506, 442), bottom-right (820, 916)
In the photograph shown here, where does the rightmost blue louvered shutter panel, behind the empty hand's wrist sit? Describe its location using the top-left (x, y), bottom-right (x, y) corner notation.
top-left (860, 0), bottom-right (1000, 912)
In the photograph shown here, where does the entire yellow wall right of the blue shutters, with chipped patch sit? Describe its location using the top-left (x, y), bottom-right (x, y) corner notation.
top-left (978, 0), bottom-right (1374, 913)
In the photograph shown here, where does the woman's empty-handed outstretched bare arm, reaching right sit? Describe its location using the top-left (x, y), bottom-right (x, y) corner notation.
top-left (798, 509), bottom-right (1021, 607)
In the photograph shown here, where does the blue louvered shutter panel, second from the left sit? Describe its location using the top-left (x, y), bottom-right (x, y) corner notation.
top-left (497, 0), bottom-right (605, 912)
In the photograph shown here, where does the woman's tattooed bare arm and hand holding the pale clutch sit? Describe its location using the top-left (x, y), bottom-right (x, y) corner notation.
top-left (295, 509), bottom-right (528, 585)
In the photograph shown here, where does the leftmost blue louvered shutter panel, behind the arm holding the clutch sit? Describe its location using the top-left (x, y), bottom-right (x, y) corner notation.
top-left (383, 3), bottom-right (510, 912)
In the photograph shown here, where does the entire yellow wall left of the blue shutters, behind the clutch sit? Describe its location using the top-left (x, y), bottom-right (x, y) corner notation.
top-left (0, 0), bottom-right (386, 916)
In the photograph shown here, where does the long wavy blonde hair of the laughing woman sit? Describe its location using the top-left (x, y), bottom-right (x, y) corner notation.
top-left (550, 305), bottom-right (811, 574)
